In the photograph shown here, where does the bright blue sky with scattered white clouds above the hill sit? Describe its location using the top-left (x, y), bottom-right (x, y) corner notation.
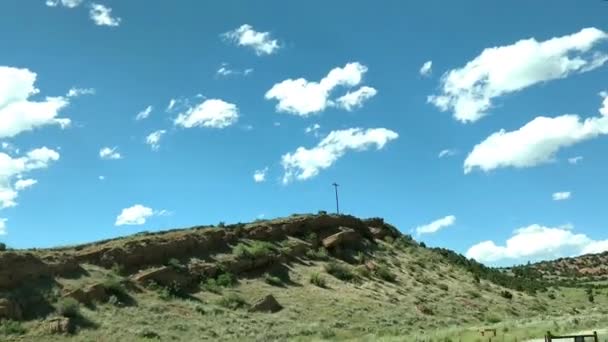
top-left (0, 0), bottom-right (608, 265)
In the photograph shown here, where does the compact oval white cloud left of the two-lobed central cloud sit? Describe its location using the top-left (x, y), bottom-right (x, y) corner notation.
top-left (174, 99), bottom-right (239, 128)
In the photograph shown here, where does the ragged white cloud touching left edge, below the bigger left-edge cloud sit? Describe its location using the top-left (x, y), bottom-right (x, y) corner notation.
top-left (0, 147), bottom-right (59, 209)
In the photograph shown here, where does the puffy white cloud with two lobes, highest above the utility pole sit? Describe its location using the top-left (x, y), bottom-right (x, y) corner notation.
top-left (265, 62), bottom-right (376, 117)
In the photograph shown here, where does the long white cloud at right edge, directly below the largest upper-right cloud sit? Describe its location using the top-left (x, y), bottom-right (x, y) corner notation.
top-left (464, 93), bottom-right (608, 173)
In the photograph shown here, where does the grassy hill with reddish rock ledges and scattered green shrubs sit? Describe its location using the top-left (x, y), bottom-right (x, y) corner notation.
top-left (0, 213), bottom-right (608, 341)
